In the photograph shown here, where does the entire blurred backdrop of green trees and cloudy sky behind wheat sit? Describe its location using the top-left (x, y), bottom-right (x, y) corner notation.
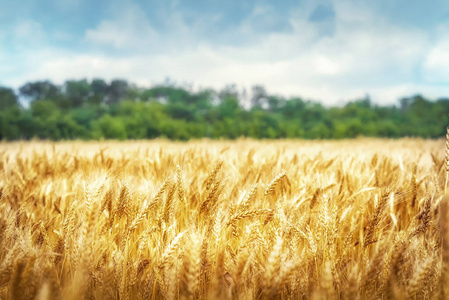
top-left (0, 0), bottom-right (449, 140)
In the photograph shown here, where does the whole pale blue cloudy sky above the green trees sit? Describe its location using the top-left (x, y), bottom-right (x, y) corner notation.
top-left (0, 0), bottom-right (449, 105)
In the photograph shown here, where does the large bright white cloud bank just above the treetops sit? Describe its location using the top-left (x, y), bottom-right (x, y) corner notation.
top-left (0, 1), bottom-right (449, 104)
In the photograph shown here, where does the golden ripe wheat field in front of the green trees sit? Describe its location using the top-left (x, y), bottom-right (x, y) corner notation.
top-left (0, 139), bottom-right (449, 299)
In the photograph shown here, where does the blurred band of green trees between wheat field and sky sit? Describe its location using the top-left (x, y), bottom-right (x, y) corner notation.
top-left (0, 79), bottom-right (449, 140)
